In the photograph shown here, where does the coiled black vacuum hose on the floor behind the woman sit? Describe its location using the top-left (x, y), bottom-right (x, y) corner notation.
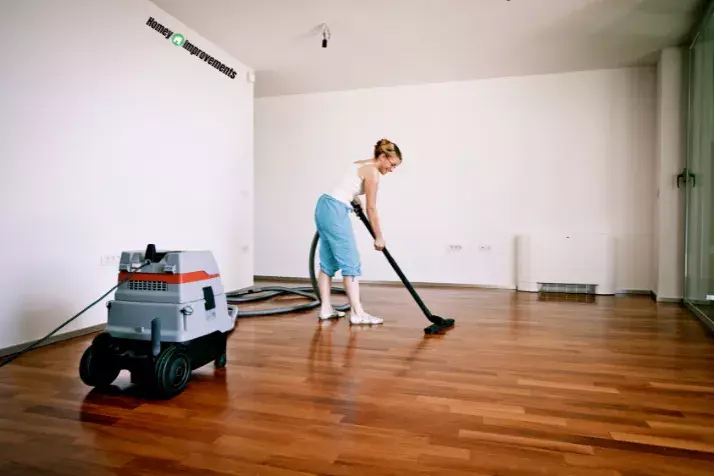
top-left (226, 232), bottom-right (350, 317)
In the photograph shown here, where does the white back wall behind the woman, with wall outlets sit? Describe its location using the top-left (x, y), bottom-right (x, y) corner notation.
top-left (255, 67), bottom-right (657, 291)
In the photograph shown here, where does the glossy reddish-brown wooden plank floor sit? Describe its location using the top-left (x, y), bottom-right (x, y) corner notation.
top-left (0, 286), bottom-right (714, 476)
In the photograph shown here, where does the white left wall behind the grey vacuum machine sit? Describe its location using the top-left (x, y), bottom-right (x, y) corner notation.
top-left (0, 0), bottom-right (253, 348)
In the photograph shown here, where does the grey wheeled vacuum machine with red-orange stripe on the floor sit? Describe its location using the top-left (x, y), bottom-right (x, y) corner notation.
top-left (79, 244), bottom-right (237, 399)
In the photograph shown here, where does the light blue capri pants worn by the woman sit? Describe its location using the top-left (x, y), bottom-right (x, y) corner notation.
top-left (315, 194), bottom-right (362, 277)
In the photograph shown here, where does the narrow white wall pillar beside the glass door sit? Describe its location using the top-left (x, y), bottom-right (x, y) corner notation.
top-left (653, 48), bottom-right (687, 300)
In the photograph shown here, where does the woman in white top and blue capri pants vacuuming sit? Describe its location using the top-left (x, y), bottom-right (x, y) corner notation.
top-left (315, 139), bottom-right (402, 324)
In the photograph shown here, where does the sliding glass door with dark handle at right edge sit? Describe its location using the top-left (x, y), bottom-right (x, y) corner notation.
top-left (677, 3), bottom-right (714, 329)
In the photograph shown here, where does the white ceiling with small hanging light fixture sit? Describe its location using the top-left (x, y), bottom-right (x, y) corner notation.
top-left (153, 0), bottom-right (706, 97)
